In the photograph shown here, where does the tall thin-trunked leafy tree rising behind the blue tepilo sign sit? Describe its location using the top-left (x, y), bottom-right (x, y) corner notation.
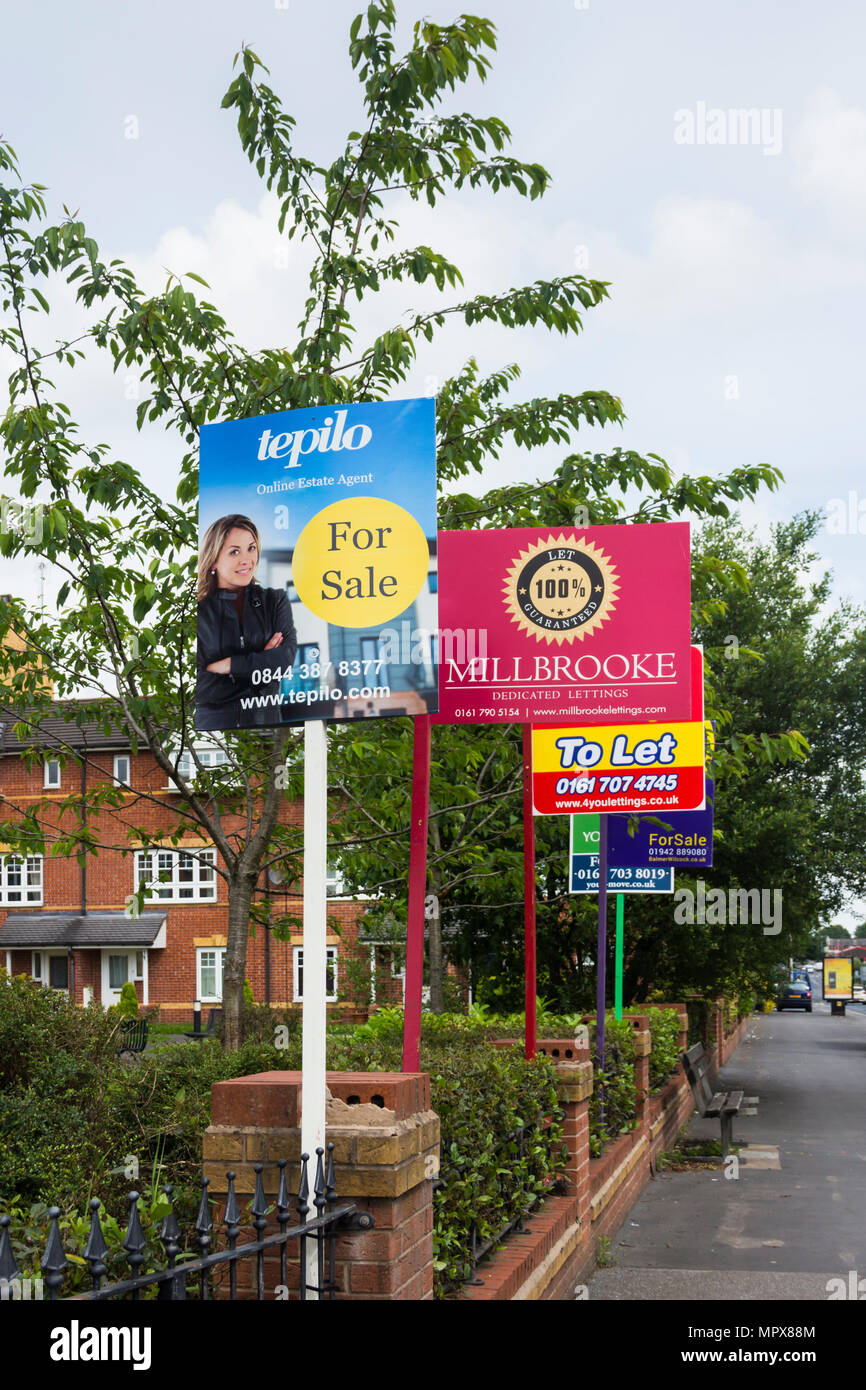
top-left (0, 0), bottom-right (670, 1047)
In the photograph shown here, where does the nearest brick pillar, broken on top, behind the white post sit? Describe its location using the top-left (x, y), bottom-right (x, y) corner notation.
top-left (202, 1072), bottom-right (439, 1301)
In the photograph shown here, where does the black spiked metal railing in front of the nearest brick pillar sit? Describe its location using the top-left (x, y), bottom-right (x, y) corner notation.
top-left (0, 1144), bottom-right (373, 1301)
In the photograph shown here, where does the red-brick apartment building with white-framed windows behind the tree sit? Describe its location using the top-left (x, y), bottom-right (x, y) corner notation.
top-left (0, 714), bottom-right (402, 1023)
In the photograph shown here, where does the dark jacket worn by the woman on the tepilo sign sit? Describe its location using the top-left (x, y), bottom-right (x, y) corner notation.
top-left (196, 582), bottom-right (297, 728)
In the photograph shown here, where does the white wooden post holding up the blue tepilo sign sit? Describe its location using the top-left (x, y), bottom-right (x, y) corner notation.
top-left (300, 719), bottom-right (328, 1300)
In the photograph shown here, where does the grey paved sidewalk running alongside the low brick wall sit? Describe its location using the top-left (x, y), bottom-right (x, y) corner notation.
top-left (589, 1002), bottom-right (866, 1301)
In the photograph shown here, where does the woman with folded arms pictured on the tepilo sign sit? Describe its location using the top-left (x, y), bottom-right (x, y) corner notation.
top-left (196, 514), bottom-right (297, 730)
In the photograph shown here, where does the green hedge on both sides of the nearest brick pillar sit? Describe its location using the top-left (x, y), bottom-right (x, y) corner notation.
top-left (0, 976), bottom-right (566, 1297)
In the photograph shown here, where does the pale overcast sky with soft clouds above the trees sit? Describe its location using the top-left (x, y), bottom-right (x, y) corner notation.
top-left (0, 0), bottom-right (866, 934)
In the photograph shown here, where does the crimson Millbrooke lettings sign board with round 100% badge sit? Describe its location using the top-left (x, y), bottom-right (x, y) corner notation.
top-left (434, 521), bottom-right (691, 726)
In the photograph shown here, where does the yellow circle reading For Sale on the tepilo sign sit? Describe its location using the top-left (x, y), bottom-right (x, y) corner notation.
top-left (292, 498), bottom-right (430, 627)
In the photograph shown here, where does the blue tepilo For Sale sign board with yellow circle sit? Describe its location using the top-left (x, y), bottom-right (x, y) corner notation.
top-left (196, 398), bottom-right (438, 730)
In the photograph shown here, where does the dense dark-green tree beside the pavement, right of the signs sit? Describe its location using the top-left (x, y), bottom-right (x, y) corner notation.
top-left (614, 513), bottom-right (866, 997)
